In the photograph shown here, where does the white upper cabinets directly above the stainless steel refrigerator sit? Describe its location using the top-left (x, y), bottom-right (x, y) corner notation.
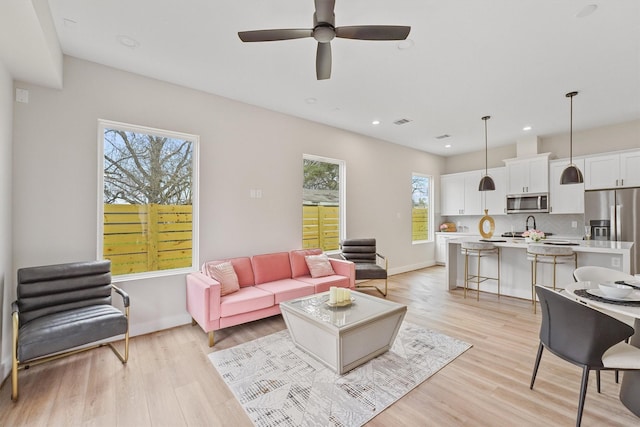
top-left (584, 150), bottom-right (640, 190)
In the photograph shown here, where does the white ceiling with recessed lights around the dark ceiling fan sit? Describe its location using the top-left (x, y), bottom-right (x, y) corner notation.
top-left (11, 0), bottom-right (640, 156)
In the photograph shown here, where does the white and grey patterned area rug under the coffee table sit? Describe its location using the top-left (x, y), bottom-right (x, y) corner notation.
top-left (209, 322), bottom-right (471, 427)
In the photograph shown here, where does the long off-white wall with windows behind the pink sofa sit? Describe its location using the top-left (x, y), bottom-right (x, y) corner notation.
top-left (13, 57), bottom-right (444, 342)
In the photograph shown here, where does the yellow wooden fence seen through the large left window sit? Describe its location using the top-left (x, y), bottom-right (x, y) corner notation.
top-left (103, 204), bottom-right (193, 275)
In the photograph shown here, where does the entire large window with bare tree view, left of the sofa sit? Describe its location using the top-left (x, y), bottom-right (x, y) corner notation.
top-left (98, 120), bottom-right (198, 277)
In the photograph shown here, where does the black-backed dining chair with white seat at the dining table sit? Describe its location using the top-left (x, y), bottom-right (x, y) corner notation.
top-left (529, 285), bottom-right (640, 426)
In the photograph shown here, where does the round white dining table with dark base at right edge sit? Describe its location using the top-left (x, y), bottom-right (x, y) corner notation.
top-left (563, 281), bottom-right (640, 417)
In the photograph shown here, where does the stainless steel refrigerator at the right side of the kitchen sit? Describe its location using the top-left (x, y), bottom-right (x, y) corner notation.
top-left (584, 188), bottom-right (640, 274)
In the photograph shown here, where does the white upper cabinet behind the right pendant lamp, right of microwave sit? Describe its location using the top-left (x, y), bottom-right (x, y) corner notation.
top-left (549, 158), bottom-right (585, 214)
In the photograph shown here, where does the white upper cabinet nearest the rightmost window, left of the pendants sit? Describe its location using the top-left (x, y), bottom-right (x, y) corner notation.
top-left (440, 171), bottom-right (482, 216)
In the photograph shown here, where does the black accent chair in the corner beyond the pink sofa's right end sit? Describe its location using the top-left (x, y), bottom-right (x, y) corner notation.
top-left (340, 238), bottom-right (389, 297)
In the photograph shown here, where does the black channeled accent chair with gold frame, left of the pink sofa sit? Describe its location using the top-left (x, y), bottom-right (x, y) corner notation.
top-left (11, 260), bottom-right (129, 401)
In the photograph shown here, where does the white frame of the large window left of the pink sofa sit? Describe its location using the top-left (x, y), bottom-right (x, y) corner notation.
top-left (96, 119), bottom-right (200, 283)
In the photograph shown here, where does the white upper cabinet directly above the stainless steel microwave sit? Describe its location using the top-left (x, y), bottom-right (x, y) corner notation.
top-left (504, 153), bottom-right (551, 194)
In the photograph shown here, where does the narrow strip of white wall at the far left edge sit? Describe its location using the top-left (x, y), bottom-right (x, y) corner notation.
top-left (0, 61), bottom-right (15, 379)
